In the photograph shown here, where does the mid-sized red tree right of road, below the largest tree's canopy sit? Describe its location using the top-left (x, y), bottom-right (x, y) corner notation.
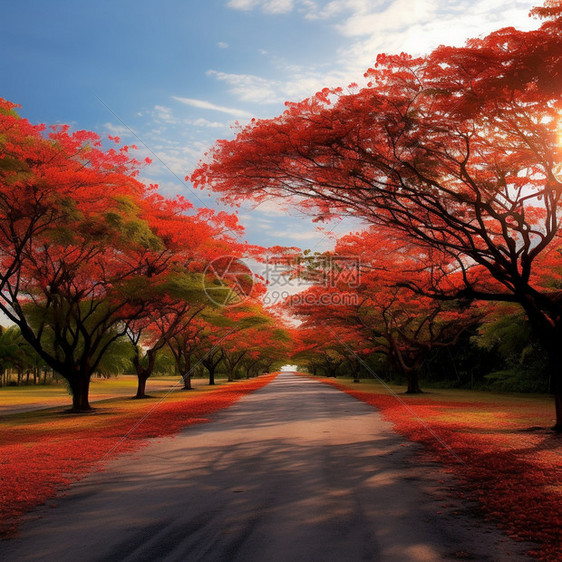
top-left (288, 228), bottom-right (480, 393)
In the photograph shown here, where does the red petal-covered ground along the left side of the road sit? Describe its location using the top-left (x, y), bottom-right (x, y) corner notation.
top-left (0, 373), bottom-right (276, 537)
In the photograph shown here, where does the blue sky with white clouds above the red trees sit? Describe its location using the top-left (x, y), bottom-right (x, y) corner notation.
top-left (0, 0), bottom-right (539, 250)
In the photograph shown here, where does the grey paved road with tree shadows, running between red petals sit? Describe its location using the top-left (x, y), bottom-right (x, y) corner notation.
top-left (0, 373), bottom-right (529, 562)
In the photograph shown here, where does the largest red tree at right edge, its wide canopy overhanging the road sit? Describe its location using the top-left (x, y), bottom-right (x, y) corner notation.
top-left (191, 1), bottom-right (562, 431)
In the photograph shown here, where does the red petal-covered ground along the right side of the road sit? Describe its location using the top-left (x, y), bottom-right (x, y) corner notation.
top-left (324, 379), bottom-right (562, 561)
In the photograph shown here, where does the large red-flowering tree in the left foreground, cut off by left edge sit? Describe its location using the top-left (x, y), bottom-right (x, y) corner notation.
top-left (0, 100), bottom-right (243, 411)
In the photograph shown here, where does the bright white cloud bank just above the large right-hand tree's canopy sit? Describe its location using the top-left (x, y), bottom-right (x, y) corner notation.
top-left (222, 0), bottom-right (540, 104)
